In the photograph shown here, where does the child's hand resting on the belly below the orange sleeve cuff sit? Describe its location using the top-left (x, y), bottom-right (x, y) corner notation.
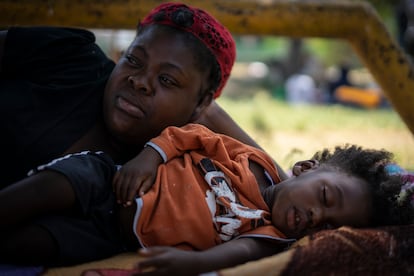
top-left (112, 147), bottom-right (162, 206)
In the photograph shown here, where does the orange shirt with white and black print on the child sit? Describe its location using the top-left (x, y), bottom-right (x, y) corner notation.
top-left (134, 124), bottom-right (285, 250)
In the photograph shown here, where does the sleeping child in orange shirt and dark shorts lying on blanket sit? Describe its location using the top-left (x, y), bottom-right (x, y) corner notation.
top-left (0, 124), bottom-right (414, 274)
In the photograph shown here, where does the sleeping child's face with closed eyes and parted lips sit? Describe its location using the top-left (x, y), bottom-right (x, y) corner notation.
top-left (272, 167), bottom-right (371, 238)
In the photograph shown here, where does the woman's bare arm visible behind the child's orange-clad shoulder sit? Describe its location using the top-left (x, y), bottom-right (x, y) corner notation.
top-left (195, 101), bottom-right (287, 180)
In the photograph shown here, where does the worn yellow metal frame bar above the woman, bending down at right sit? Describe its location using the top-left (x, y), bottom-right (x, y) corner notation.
top-left (0, 0), bottom-right (414, 134)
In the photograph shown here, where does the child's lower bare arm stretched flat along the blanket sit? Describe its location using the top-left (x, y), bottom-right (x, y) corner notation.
top-left (137, 238), bottom-right (282, 275)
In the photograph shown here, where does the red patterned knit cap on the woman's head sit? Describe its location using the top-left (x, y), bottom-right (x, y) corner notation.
top-left (140, 3), bottom-right (236, 98)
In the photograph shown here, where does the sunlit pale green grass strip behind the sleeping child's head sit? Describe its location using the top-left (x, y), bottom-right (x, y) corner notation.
top-left (218, 92), bottom-right (414, 170)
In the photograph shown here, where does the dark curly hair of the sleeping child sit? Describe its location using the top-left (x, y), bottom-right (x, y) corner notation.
top-left (313, 145), bottom-right (414, 226)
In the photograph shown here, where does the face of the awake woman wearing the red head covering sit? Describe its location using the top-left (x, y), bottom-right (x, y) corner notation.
top-left (103, 26), bottom-right (209, 146)
